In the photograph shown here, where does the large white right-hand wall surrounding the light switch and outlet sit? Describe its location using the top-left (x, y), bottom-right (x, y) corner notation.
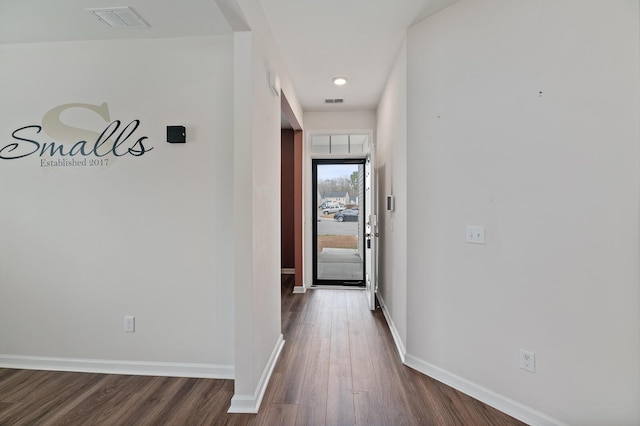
top-left (407, 0), bottom-right (640, 425)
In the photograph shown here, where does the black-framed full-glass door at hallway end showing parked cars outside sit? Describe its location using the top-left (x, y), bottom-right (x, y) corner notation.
top-left (312, 159), bottom-right (366, 287)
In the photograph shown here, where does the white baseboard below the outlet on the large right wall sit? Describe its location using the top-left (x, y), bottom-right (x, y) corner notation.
top-left (405, 354), bottom-right (566, 426)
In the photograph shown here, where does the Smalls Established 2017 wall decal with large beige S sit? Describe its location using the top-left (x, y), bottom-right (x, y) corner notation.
top-left (0, 102), bottom-right (153, 167)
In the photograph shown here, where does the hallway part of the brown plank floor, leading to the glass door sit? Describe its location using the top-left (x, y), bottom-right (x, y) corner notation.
top-left (253, 275), bottom-right (522, 426)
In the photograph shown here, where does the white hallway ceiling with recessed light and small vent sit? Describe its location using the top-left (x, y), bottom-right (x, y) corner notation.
top-left (262, 0), bottom-right (457, 111)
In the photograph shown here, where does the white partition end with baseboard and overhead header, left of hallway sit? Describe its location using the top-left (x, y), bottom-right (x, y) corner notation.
top-left (230, 0), bottom-right (302, 412)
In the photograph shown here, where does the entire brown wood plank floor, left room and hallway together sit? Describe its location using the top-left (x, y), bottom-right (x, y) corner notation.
top-left (0, 276), bottom-right (522, 426)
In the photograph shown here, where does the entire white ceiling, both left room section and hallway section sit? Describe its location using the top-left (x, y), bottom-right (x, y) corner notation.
top-left (0, 0), bottom-right (457, 111)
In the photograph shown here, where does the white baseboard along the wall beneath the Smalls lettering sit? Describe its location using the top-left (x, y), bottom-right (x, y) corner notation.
top-left (0, 354), bottom-right (235, 379)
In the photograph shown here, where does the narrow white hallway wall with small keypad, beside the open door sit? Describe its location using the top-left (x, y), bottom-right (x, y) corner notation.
top-left (376, 42), bottom-right (407, 357)
